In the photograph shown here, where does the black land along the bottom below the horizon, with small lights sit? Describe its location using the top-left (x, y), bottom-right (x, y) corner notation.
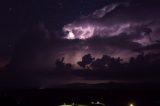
top-left (0, 85), bottom-right (160, 106)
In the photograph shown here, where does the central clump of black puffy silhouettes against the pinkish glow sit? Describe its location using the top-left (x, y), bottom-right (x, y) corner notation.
top-left (77, 54), bottom-right (123, 70)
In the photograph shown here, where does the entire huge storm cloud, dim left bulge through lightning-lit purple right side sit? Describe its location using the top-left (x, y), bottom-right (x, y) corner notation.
top-left (4, 2), bottom-right (159, 66)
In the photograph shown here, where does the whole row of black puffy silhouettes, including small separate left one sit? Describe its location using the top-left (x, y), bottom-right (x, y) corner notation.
top-left (56, 52), bottom-right (160, 71)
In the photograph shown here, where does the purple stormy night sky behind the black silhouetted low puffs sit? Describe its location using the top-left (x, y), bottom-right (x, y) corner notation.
top-left (0, 0), bottom-right (160, 88)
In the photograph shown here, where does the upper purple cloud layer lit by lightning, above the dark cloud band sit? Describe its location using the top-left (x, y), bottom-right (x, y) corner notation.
top-left (63, 3), bottom-right (160, 44)
